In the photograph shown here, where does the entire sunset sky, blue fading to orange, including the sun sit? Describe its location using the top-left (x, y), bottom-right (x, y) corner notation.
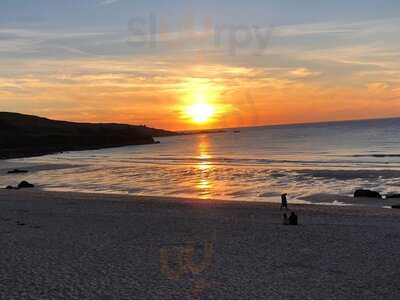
top-left (0, 0), bottom-right (400, 130)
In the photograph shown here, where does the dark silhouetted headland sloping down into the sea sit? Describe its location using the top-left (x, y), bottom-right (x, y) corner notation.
top-left (0, 112), bottom-right (175, 159)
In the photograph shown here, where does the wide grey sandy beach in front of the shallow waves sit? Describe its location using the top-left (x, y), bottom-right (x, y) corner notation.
top-left (0, 190), bottom-right (400, 299)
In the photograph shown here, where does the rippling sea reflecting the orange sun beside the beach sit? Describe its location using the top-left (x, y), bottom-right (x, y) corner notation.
top-left (0, 119), bottom-right (400, 204)
